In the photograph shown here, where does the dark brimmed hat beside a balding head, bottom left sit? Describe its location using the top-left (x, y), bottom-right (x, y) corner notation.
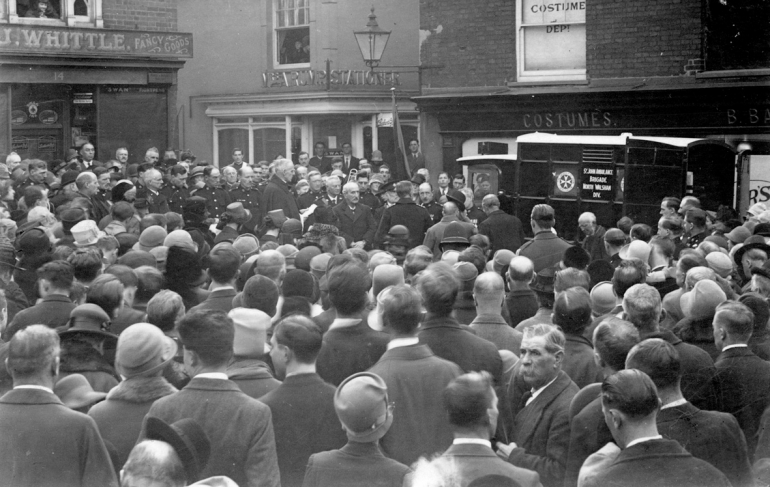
top-left (145, 416), bottom-right (211, 484)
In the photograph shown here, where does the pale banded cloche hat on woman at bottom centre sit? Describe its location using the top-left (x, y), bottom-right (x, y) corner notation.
top-left (334, 372), bottom-right (393, 443)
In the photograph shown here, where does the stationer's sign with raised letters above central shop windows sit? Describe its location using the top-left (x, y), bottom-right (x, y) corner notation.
top-left (262, 69), bottom-right (401, 88)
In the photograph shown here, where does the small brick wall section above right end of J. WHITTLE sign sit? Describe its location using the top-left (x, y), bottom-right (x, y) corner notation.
top-left (102, 0), bottom-right (177, 32)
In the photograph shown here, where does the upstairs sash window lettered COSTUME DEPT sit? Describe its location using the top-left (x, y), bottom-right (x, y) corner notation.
top-left (516, 0), bottom-right (587, 82)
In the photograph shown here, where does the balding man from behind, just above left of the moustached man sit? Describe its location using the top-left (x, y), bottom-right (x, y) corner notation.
top-left (470, 272), bottom-right (526, 357)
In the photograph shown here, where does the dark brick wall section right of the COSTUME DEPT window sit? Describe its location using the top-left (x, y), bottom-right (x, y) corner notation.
top-left (586, 0), bottom-right (703, 78)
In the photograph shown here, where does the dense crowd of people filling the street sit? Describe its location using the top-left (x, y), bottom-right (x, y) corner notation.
top-left (0, 144), bottom-right (770, 487)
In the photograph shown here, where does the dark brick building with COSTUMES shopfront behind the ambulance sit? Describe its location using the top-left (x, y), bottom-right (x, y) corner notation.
top-left (414, 0), bottom-right (770, 211)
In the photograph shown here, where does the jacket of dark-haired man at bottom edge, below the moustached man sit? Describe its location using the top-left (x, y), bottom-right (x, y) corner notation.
top-left (444, 443), bottom-right (540, 487)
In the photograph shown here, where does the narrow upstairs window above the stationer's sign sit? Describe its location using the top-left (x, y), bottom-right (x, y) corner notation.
top-left (273, 0), bottom-right (310, 66)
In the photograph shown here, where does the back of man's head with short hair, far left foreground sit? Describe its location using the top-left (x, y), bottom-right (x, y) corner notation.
top-left (7, 325), bottom-right (59, 381)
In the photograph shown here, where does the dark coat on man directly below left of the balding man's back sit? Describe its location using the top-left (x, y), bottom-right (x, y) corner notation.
top-left (419, 316), bottom-right (503, 386)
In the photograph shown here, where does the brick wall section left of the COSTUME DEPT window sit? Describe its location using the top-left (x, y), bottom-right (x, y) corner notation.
top-left (420, 0), bottom-right (516, 88)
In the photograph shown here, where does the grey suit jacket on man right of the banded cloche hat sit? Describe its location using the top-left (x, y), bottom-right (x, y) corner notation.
top-left (369, 345), bottom-right (463, 465)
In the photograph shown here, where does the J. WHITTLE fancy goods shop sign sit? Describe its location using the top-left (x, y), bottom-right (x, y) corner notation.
top-left (0, 25), bottom-right (193, 58)
